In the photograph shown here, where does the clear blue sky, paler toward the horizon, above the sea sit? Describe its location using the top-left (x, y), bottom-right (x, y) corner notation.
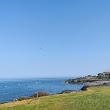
top-left (0, 0), bottom-right (110, 78)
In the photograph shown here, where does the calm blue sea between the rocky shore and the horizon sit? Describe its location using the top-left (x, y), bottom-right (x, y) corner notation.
top-left (0, 78), bottom-right (83, 103)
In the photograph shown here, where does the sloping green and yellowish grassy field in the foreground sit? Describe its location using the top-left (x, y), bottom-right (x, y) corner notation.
top-left (0, 87), bottom-right (110, 110)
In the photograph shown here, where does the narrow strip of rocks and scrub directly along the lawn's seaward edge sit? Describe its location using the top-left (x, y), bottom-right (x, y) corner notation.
top-left (0, 81), bottom-right (110, 105)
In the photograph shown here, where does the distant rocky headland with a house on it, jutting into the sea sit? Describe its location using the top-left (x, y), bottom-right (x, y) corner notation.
top-left (65, 70), bottom-right (110, 87)
